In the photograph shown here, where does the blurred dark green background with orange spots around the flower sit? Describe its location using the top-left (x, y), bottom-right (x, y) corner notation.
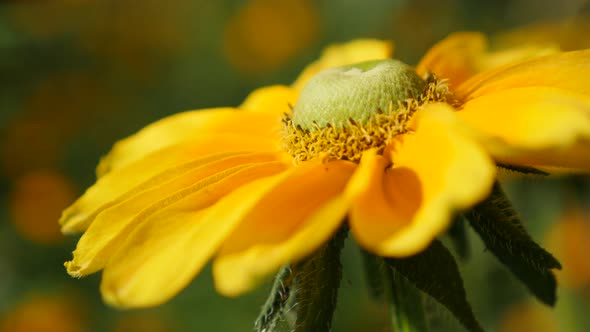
top-left (0, 0), bottom-right (590, 332)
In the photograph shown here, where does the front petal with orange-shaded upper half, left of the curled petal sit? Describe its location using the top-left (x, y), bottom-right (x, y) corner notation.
top-left (213, 161), bottom-right (355, 296)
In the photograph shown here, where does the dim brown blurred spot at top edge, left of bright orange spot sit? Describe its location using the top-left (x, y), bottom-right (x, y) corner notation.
top-left (77, 0), bottom-right (192, 80)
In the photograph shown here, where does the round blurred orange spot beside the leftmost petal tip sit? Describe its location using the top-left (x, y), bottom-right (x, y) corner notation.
top-left (10, 171), bottom-right (75, 244)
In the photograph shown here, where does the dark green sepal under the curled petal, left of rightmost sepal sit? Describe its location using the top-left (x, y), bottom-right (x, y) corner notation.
top-left (385, 240), bottom-right (483, 332)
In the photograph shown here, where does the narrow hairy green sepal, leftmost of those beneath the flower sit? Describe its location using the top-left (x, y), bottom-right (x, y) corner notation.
top-left (254, 265), bottom-right (293, 332)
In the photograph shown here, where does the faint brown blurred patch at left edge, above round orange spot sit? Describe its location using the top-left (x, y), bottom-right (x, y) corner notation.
top-left (0, 73), bottom-right (122, 178)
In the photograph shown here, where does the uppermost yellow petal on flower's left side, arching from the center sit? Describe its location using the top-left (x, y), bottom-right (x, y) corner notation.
top-left (97, 108), bottom-right (280, 177)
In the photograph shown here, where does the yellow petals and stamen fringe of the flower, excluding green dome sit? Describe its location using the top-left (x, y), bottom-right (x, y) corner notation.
top-left (61, 33), bottom-right (590, 307)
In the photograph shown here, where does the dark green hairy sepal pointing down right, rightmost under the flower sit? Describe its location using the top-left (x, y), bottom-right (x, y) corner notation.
top-left (466, 183), bottom-right (561, 306)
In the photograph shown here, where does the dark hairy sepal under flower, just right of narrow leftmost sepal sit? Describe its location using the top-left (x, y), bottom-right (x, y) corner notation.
top-left (293, 227), bottom-right (348, 332)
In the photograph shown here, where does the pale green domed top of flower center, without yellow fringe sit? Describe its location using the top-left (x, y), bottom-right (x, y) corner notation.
top-left (292, 60), bottom-right (426, 129)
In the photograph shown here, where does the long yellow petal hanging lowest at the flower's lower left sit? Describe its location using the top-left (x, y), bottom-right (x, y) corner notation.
top-left (101, 169), bottom-right (289, 308)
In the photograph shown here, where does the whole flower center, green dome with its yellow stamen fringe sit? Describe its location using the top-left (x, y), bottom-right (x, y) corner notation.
top-left (283, 60), bottom-right (452, 162)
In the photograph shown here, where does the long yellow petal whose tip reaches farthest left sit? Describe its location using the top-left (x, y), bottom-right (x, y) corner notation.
top-left (60, 134), bottom-right (278, 233)
